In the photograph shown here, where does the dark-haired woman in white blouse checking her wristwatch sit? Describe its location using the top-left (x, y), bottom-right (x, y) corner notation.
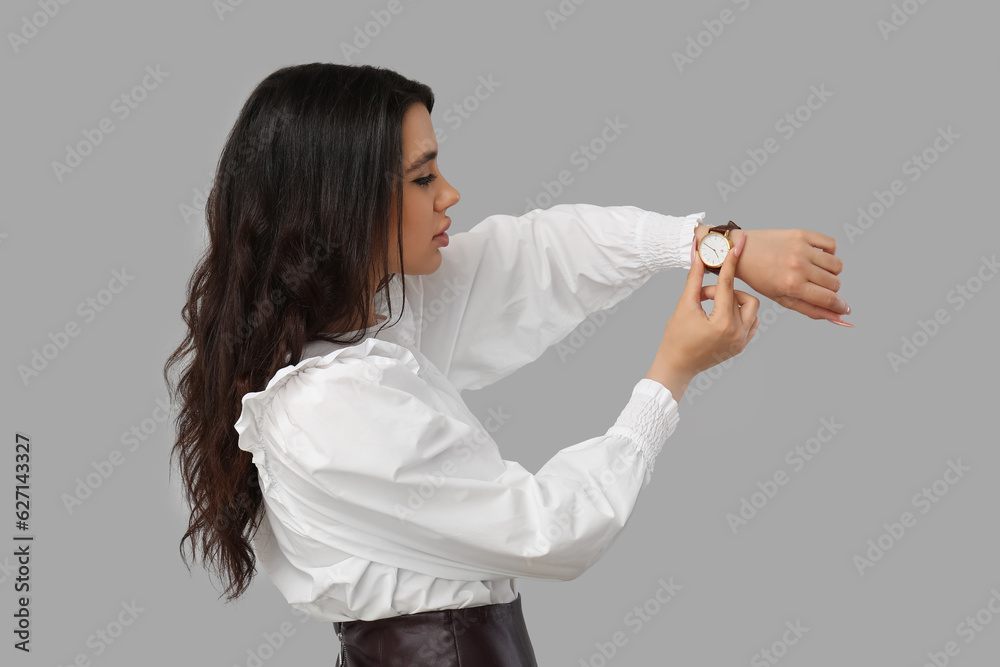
top-left (164, 63), bottom-right (849, 666)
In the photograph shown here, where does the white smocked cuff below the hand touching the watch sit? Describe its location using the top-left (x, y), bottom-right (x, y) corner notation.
top-left (607, 378), bottom-right (679, 483)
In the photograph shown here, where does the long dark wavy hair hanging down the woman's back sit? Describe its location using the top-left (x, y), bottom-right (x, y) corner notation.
top-left (163, 63), bottom-right (434, 601)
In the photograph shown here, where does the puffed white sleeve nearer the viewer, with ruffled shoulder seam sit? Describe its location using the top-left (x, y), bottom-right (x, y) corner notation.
top-left (236, 339), bottom-right (678, 580)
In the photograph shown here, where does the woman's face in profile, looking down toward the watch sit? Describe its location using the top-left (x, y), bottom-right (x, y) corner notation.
top-left (389, 104), bottom-right (460, 275)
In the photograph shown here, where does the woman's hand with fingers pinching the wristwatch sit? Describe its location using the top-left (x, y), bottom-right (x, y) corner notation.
top-left (646, 234), bottom-right (760, 400)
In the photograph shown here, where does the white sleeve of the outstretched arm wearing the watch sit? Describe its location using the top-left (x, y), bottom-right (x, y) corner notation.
top-left (407, 204), bottom-right (705, 391)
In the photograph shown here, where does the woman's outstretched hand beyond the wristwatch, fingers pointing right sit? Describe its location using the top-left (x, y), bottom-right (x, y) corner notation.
top-left (730, 229), bottom-right (850, 322)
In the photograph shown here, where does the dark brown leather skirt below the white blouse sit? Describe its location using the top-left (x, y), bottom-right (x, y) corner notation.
top-left (333, 593), bottom-right (538, 667)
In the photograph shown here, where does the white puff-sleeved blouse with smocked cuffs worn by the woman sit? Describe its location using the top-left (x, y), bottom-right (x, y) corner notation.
top-left (235, 204), bottom-right (704, 621)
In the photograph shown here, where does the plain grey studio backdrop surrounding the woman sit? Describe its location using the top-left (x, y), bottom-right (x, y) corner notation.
top-left (0, 0), bottom-right (1000, 667)
